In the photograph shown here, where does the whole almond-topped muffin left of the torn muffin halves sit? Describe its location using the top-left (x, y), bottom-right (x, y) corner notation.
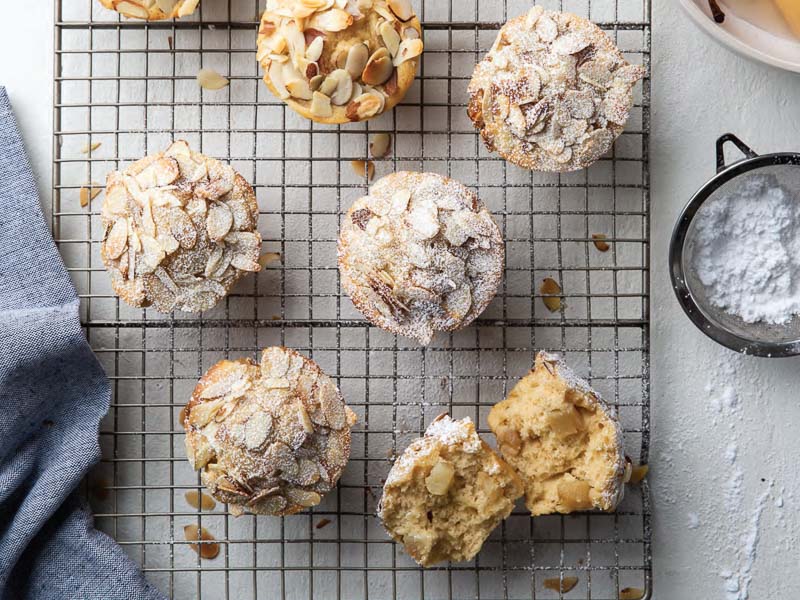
top-left (183, 347), bottom-right (356, 515)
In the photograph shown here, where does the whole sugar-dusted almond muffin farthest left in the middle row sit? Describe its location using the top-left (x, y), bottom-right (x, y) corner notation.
top-left (100, 141), bottom-right (261, 312)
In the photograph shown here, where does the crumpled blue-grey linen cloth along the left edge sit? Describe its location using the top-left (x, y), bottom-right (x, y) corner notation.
top-left (0, 87), bottom-right (163, 600)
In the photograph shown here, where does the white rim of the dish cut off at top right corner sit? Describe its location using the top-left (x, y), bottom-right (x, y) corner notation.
top-left (680, 0), bottom-right (800, 73)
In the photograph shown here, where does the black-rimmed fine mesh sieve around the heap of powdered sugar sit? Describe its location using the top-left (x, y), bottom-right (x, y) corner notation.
top-left (669, 133), bottom-right (800, 357)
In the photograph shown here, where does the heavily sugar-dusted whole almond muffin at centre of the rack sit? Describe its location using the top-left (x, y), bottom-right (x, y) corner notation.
top-left (338, 171), bottom-right (505, 344)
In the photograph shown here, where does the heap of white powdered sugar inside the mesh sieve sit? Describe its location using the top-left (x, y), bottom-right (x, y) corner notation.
top-left (692, 174), bottom-right (800, 324)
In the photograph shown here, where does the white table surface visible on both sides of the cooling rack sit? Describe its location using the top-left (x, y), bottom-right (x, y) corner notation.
top-left (0, 0), bottom-right (800, 600)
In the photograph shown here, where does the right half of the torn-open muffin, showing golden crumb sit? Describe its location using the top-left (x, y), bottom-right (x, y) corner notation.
top-left (489, 352), bottom-right (625, 516)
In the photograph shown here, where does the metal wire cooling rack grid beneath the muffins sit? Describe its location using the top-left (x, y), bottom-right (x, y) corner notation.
top-left (52, 0), bottom-right (652, 600)
